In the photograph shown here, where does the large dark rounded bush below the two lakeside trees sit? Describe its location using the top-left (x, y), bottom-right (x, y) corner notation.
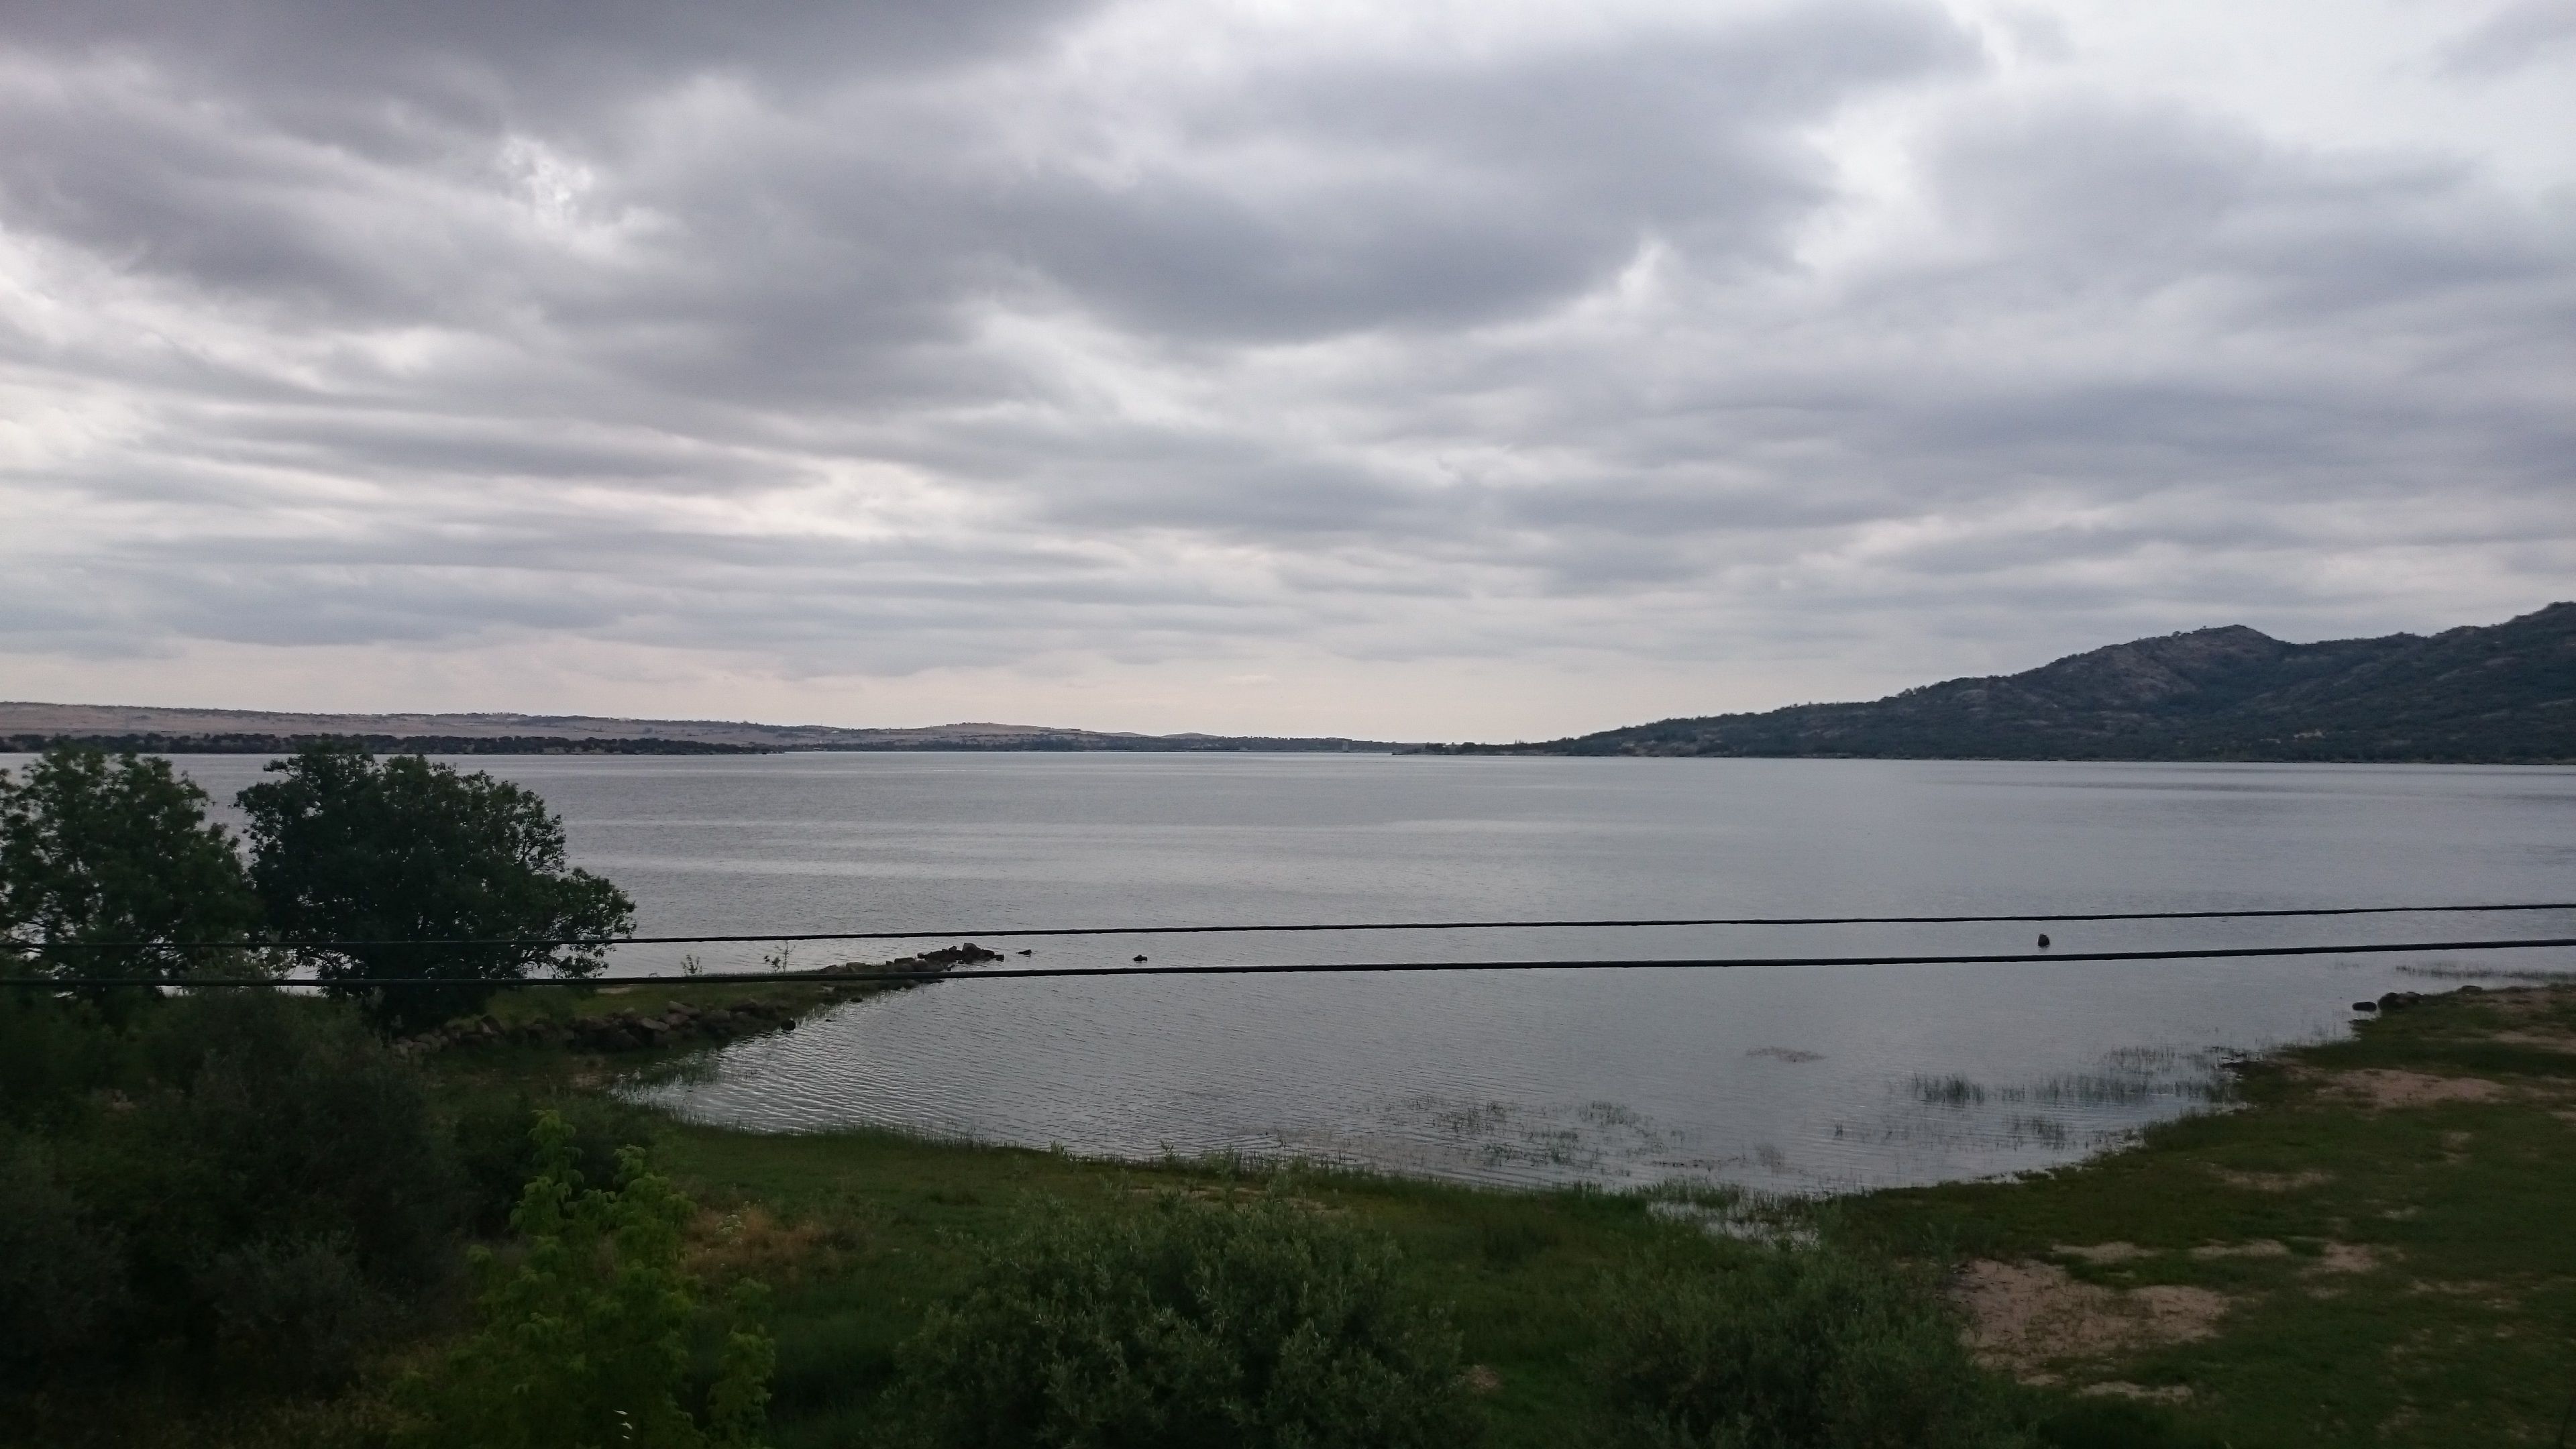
top-left (19, 990), bottom-right (461, 1395)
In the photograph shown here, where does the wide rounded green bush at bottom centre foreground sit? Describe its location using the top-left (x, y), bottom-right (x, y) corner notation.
top-left (896, 1199), bottom-right (1481, 1449)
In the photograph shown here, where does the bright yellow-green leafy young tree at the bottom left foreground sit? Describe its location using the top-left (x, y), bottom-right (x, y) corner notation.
top-left (407, 1112), bottom-right (775, 1449)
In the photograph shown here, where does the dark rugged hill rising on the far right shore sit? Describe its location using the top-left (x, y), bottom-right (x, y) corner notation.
top-left (1427, 603), bottom-right (2576, 763)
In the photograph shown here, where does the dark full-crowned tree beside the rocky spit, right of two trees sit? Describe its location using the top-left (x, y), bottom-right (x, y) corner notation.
top-left (239, 743), bottom-right (634, 1031)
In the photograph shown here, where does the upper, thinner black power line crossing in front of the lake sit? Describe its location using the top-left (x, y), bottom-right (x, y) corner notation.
top-left (10, 900), bottom-right (2576, 959)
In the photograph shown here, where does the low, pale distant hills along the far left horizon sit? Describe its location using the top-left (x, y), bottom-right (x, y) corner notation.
top-left (0, 701), bottom-right (1401, 755)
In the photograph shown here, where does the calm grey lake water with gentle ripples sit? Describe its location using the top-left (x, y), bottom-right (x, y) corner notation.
top-left (25, 753), bottom-right (2576, 1191)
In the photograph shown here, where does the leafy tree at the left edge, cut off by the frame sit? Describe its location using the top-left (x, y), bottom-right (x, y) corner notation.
top-left (0, 745), bottom-right (258, 977)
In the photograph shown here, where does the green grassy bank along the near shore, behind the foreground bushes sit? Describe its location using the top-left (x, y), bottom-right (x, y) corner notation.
top-left (412, 987), bottom-right (2576, 1446)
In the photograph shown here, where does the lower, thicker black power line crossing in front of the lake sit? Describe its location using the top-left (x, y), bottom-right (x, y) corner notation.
top-left (0, 936), bottom-right (2576, 990)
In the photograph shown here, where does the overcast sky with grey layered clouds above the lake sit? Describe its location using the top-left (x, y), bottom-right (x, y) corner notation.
top-left (0, 0), bottom-right (2576, 737)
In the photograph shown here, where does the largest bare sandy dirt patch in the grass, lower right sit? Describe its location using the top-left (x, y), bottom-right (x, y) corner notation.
top-left (1957, 1258), bottom-right (2229, 1382)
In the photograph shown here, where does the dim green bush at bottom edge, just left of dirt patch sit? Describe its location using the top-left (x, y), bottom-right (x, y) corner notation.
top-left (1600, 1245), bottom-right (2020, 1449)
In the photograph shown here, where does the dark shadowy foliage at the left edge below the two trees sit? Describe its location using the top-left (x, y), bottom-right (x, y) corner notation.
top-left (0, 993), bottom-right (464, 1395)
